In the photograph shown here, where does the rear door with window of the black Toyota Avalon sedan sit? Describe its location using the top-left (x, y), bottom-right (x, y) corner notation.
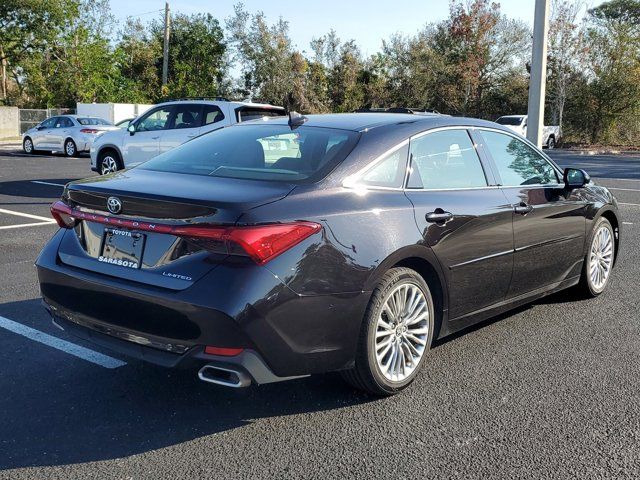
top-left (406, 128), bottom-right (513, 320)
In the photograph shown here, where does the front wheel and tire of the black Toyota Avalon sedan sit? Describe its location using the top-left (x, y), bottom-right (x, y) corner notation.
top-left (578, 217), bottom-right (615, 297)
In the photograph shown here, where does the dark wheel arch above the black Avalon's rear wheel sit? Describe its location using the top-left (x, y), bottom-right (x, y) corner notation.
top-left (365, 245), bottom-right (449, 340)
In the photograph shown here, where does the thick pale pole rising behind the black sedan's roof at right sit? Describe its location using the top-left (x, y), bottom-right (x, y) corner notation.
top-left (527, 0), bottom-right (549, 148)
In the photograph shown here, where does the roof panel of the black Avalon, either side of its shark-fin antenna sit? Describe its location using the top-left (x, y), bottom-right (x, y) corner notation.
top-left (250, 113), bottom-right (504, 132)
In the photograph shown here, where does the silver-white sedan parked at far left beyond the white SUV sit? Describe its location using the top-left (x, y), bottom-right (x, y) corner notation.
top-left (22, 115), bottom-right (118, 157)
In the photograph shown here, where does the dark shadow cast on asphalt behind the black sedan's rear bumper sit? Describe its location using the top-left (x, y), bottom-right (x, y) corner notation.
top-left (0, 300), bottom-right (374, 470)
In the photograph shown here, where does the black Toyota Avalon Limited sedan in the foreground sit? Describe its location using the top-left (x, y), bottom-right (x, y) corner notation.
top-left (37, 113), bottom-right (621, 395)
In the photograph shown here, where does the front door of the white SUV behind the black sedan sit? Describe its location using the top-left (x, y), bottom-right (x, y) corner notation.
top-left (122, 105), bottom-right (174, 167)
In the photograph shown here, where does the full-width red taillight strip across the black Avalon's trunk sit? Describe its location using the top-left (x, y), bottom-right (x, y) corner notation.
top-left (51, 201), bottom-right (322, 264)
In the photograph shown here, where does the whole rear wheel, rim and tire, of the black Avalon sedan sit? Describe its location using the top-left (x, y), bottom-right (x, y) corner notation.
top-left (342, 268), bottom-right (434, 396)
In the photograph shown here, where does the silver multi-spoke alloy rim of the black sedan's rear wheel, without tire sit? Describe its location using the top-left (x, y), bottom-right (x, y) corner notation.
top-left (375, 283), bottom-right (429, 382)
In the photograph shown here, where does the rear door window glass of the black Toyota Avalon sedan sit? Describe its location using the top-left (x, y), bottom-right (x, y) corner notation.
top-left (407, 130), bottom-right (487, 190)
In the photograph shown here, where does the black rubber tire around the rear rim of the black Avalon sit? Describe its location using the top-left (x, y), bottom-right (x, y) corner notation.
top-left (340, 267), bottom-right (435, 396)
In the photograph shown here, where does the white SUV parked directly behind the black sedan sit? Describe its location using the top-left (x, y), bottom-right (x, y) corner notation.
top-left (91, 98), bottom-right (285, 175)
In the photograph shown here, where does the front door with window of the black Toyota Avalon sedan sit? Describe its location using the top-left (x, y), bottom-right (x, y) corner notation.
top-left (479, 129), bottom-right (586, 297)
